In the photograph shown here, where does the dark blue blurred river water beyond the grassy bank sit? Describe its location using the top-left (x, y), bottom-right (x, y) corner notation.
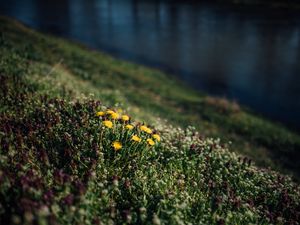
top-left (0, 0), bottom-right (300, 130)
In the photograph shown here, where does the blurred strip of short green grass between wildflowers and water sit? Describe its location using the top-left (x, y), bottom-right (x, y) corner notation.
top-left (0, 18), bottom-right (300, 178)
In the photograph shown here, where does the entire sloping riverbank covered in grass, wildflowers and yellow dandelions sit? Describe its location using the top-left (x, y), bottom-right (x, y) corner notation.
top-left (0, 17), bottom-right (300, 224)
